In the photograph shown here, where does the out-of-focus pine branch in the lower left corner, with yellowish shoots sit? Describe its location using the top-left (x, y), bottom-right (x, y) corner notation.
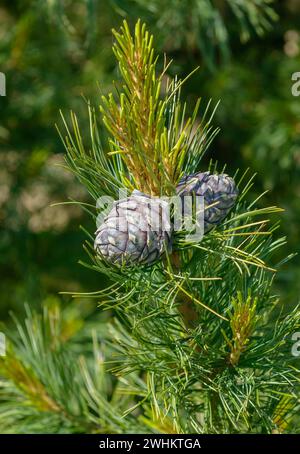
top-left (0, 303), bottom-right (149, 433)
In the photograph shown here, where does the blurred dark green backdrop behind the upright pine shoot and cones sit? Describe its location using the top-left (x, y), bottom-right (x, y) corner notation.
top-left (0, 0), bottom-right (300, 319)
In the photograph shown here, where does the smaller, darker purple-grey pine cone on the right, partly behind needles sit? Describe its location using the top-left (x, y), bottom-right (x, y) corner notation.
top-left (176, 172), bottom-right (239, 233)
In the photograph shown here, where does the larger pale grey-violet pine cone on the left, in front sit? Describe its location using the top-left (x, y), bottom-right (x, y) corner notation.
top-left (94, 191), bottom-right (171, 266)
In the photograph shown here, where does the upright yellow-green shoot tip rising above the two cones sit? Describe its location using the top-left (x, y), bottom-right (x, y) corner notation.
top-left (101, 21), bottom-right (215, 195)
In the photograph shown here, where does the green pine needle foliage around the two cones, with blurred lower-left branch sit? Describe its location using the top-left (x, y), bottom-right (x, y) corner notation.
top-left (0, 21), bottom-right (300, 433)
